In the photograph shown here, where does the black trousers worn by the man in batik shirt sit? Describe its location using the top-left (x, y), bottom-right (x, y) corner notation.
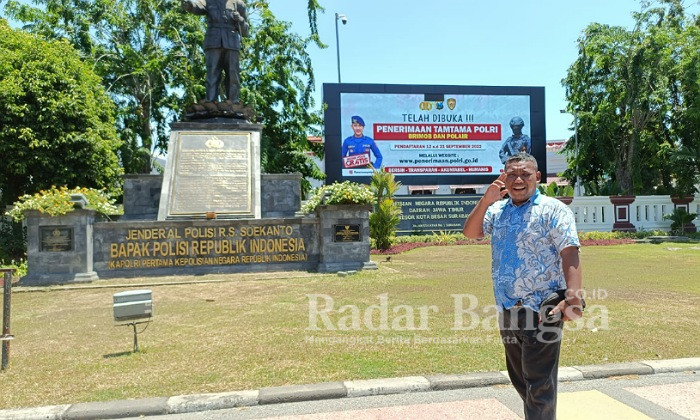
top-left (499, 307), bottom-right (563, 420)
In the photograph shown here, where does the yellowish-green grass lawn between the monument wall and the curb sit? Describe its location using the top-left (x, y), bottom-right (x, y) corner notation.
top-left (0, 243), bottom-right (700, 408)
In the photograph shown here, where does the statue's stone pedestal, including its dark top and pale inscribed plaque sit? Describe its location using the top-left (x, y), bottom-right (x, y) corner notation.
top-left (158, 119), bottom-right (262, 220)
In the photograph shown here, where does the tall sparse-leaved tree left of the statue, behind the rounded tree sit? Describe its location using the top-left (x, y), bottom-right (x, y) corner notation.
top-left (6, 0), bottom-right (204, 172)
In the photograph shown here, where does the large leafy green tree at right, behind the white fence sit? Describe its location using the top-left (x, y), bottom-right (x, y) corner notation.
top-left (563, 0), bottom-right (700, 194)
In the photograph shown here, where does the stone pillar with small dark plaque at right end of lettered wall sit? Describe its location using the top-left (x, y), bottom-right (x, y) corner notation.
top-left (316, 204), bottom-right (377, 272)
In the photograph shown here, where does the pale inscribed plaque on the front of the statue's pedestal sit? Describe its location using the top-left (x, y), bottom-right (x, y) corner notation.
top-left (159, 131), bottom-right (259, 219)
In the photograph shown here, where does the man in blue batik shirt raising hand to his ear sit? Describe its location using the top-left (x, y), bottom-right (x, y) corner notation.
top-left (464, 153), bottom-right (583, 419)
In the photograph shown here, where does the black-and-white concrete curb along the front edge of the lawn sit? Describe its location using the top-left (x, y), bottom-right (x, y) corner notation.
top-left (0, 357), bottom-right (700, 420)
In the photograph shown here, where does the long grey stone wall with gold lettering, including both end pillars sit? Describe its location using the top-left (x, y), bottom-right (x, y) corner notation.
top-left (21, 205), bottom-right (377, 285)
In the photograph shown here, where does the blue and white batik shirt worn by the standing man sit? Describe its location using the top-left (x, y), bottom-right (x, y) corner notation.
top-left (483, 191), bottom-right (581, 311)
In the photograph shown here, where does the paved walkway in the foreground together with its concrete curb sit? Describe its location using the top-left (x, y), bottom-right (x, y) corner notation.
top-left (0, 358), bottom-right (700, 420)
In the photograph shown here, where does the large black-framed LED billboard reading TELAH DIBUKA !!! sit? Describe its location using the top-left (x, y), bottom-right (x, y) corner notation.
top-left (323, 84), bottom-right (547, 185)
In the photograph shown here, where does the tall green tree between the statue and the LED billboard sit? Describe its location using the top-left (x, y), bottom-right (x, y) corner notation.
top-left (241, 0), bottom-right (324, 191)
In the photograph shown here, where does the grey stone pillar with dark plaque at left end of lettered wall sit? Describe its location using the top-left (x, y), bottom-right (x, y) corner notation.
top-left (20, 209), bottom-right (98, 286)
